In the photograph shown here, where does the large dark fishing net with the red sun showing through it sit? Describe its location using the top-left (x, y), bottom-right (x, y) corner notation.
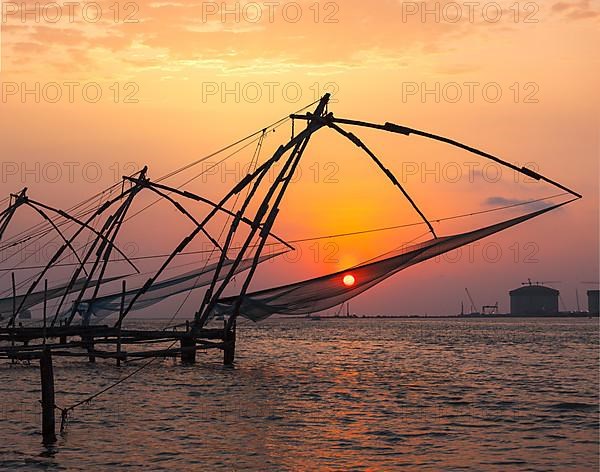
top-left (213, 203), bottom-right (565, 321)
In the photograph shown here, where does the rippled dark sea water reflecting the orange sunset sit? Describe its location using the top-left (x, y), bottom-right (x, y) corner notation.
top-left (0, 318), bottom-right (599, 471)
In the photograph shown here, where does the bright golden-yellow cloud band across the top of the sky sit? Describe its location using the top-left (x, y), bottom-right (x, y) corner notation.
top-left (3, 0), bottom-right (510, 74)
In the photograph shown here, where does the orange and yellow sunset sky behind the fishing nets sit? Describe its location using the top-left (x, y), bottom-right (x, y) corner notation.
top-left (0, 0), bottom-right (600, 315)
